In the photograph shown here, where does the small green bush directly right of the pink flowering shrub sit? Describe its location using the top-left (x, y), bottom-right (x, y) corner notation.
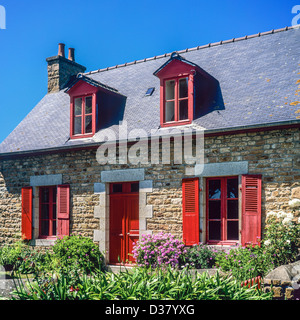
top-left (185, 243), bottom-right (218, 269)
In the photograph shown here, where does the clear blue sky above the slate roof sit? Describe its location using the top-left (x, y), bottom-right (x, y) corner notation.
top-left (0, 0), bottom-right (300, 142)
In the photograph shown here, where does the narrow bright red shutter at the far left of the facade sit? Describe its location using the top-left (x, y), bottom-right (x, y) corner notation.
top-left (21, 187), bottom-right (32, 240)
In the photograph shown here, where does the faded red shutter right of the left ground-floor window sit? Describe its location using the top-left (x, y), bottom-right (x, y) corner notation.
top-left (57, 185), bottom-right (70, 238)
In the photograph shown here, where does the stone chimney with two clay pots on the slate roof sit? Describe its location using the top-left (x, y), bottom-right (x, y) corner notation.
top-left (46, 43), bottom-right (86, 93)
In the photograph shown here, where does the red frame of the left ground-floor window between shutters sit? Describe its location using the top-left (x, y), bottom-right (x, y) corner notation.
top-left (39, 186), bottom-right (57, 239)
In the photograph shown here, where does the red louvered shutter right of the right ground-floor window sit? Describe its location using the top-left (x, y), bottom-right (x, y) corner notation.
top-left (242, 175), bottom-right (261, 245)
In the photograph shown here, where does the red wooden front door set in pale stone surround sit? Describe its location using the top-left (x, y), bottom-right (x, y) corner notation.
top-left (109, 182), bottom-right (139, 264)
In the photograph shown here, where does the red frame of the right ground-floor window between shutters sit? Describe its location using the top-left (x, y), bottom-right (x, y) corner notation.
top-left (206, 176), bottom-right (240, 245)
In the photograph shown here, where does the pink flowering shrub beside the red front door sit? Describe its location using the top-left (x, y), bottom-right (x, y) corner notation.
top-left (132, 232), bottom-right (187, 268)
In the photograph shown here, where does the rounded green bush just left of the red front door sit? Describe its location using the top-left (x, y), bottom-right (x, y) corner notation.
top-left (51, 235), bottom-right (104, 272)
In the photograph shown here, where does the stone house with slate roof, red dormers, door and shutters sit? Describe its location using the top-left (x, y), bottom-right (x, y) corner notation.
top-left (0, 27), bottom-right (300, 264)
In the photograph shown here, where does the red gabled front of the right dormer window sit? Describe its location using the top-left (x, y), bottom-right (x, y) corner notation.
top-left (154, 52), bottom-right (199, 127)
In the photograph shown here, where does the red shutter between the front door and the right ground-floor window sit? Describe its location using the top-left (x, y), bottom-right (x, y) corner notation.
top-left (182, 178), bottom-right (200, 246)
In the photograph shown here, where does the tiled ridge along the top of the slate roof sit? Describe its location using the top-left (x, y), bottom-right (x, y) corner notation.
top-left (83, 24), bottom-right (300, 75)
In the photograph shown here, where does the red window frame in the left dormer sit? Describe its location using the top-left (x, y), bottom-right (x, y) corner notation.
top-left (71, 93), bottom-right (96, 139)
